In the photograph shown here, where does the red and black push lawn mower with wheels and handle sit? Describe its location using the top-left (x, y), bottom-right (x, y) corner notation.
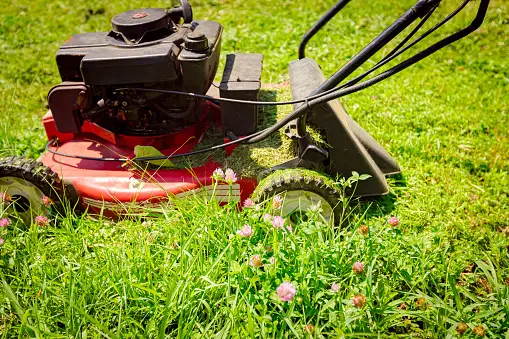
top-left (0, 0), bottom-right (489, 220)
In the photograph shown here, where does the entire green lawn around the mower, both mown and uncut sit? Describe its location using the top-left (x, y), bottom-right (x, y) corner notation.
top-left (0, 0), bottom-right (509, 338)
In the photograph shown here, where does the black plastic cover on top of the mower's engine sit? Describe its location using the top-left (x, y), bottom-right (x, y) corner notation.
top-left (56, 9), bottom-right (222, 93)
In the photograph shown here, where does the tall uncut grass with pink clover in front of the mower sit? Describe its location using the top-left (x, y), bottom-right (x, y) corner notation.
top-left (0, 178), bottom-right (509, 338)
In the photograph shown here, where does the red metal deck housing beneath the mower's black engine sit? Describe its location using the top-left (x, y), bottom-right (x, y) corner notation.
top-left (40, 102), bottom-right (257, 216)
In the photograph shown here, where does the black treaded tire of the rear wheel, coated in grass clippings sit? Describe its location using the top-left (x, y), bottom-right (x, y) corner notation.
top-left (252, 168), bottom-right (342, 224)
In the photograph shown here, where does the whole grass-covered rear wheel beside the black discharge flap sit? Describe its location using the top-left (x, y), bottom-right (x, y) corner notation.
top-left (253, 168), bottom-right (342, 223)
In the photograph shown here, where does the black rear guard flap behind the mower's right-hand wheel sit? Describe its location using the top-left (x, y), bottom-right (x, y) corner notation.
top-left (290, 58), bottom-right (400, 196)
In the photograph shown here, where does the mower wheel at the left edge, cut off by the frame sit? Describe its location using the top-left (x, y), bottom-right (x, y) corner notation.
top-left (0, 157), bottom-right (63, 224)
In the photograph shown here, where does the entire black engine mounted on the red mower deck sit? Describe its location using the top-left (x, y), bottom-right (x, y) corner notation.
top-left (48, 0), bottom-right (222, 135)
